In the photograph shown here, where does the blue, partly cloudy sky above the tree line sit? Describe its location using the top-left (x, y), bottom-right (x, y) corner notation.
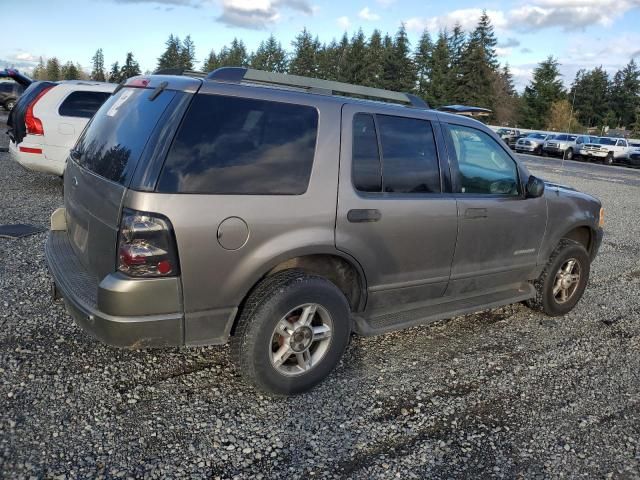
top-left (0, 0), bottom-right (640, 90)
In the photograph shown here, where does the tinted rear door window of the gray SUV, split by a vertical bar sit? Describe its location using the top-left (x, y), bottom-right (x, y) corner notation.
top-left (352, 114), bottom-right (441, 193)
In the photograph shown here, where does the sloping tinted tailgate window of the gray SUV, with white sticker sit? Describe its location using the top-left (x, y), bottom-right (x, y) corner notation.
top-left (76, 88), bottom-right (176, 185)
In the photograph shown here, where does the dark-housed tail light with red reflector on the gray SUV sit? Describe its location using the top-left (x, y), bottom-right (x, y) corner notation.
top-left (118, 209), bottom-right (180, 277)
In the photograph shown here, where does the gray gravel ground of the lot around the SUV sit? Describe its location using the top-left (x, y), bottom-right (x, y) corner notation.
top-left (0, 113), bottom-right (640, 479)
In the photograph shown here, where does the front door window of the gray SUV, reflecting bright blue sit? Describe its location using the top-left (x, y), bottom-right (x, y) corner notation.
top-left (449, 125), bottom-right (520, 196)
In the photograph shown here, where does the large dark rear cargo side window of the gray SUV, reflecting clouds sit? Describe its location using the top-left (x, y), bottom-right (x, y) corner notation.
top-left (157, 94), bottom-right (318, 195)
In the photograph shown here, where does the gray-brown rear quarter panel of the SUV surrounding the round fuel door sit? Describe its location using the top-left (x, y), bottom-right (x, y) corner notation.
top-left (125, 85), bottom-right (341, 313)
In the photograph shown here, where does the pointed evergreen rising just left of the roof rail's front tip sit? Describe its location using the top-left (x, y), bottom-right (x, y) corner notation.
top-left (382, 24), bottom-right (416, 92)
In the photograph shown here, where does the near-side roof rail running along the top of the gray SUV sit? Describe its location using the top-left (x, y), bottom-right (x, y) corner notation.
top-left (207, 67), bottom-right (429, 109)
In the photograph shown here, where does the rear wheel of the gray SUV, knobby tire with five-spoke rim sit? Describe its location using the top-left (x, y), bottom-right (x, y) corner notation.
top-left (231, 270), bottom-right (351, 395)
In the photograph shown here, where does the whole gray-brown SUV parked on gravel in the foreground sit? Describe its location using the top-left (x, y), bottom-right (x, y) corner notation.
top-left (46, 68), bottom-right (603, 394)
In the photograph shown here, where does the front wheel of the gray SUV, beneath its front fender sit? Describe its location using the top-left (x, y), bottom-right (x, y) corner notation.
top-left (526, 239), bottom-right (591, 317)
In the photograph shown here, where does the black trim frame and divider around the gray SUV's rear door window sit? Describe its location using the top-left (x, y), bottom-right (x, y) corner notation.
top-left (349, 110), bottom-right (444, 199)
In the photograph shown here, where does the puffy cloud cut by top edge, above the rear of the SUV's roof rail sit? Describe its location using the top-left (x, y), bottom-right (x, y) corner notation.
top-left (216, 0), bottom-right (314, 30)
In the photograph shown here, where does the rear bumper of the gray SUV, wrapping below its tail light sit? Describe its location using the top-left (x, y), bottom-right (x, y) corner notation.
top-left (45, 231), bottom-right (184, 348)
